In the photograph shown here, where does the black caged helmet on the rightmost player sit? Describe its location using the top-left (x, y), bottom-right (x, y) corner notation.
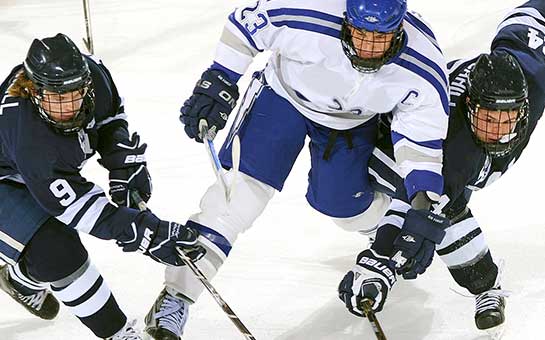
top-left (467, 53), bottom-right (528, 157)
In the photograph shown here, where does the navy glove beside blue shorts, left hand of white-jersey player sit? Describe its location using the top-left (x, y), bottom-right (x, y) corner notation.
top-left (180, 70), bottom-right (239, 143)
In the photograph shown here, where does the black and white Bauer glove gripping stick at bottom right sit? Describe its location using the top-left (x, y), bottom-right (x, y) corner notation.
top-left (338, 249), bottom-right (396, 316)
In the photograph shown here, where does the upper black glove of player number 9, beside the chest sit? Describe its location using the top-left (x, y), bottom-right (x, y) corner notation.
top-left (98, 132), bottom-right (152, 209)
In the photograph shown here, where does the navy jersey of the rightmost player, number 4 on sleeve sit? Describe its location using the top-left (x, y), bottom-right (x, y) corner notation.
top-left (370, 0), bottom-right (545, 213)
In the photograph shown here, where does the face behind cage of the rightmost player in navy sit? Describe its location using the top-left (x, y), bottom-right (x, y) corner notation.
top-left (473, 107), bottom-right (519, 143)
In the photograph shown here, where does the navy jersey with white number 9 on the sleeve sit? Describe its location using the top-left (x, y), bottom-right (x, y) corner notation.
top-left (0, 57), bottom-right (139, 239)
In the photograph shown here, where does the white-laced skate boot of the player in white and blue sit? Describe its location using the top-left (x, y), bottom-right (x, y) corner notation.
top-left (145, 288), bottom-right (189, 340)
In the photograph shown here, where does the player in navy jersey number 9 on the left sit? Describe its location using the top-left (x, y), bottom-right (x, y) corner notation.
top-left (0, 34), bottom-right (201, 340)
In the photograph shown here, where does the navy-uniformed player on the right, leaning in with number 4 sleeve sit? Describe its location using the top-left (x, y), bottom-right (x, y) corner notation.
top-left (339, 0), bottom-right (545, 333)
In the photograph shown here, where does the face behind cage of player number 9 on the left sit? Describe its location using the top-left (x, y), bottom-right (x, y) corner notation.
top-left (41, 90), bottom-right (84, 122)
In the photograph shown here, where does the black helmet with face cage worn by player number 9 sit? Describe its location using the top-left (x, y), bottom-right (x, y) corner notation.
top-left (23, 33), bottom-right (95, 134)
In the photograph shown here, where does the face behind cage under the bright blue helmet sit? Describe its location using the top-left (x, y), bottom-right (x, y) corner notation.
top-left (349, 26), bottom-right (394, 59)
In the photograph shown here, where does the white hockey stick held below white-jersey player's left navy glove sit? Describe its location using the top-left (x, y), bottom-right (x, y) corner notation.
top-left (199, 119), bottom-right (240, 202)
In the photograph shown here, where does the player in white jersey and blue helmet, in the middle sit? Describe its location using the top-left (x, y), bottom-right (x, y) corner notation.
top-left (141, 0), bottom-right (448, 339)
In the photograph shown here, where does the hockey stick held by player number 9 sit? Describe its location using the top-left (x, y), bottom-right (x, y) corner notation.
top-left (130, 191), bottom-right (256, 340)
